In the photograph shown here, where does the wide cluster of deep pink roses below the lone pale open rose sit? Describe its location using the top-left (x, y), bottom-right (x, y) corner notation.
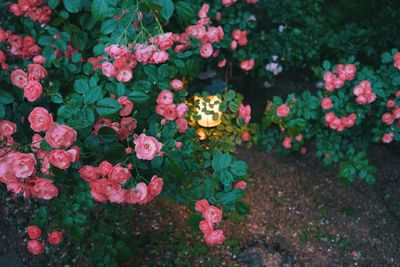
top-left (79, 161), bottom-right (164, 204)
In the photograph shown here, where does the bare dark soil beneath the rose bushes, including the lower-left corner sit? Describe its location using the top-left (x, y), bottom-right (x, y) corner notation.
top-left (0, 147), bottom-right (400, 267)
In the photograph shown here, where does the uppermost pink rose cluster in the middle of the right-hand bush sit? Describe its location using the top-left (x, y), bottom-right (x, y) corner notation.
top-left (324, 64), bottom-right (357, 92)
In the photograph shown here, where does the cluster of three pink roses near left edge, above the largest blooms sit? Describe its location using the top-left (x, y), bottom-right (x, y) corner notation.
top-left (11, 62), bottom-right (47, 102)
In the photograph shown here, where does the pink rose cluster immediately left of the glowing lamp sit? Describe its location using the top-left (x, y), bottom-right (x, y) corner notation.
top-left (156, 90), bottom-right (189, 133)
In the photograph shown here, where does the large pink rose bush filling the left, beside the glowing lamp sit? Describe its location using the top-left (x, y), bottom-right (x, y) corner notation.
top-left (0, 0), bottom-right (253, 266)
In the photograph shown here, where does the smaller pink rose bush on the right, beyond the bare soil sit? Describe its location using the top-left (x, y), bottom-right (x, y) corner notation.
top-left (255, 50), bottom-right (400, 183)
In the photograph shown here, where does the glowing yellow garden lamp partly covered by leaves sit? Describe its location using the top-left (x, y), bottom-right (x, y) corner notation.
top-left (194, 95), bottom-right (222, 128)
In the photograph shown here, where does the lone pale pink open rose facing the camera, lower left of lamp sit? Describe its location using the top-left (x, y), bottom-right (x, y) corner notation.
top-left (134, 133), bottom-right (162, 160)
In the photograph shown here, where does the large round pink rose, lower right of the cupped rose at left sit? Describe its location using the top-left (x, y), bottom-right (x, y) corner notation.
top-left (45, 123), bottom-right (77, 148)
